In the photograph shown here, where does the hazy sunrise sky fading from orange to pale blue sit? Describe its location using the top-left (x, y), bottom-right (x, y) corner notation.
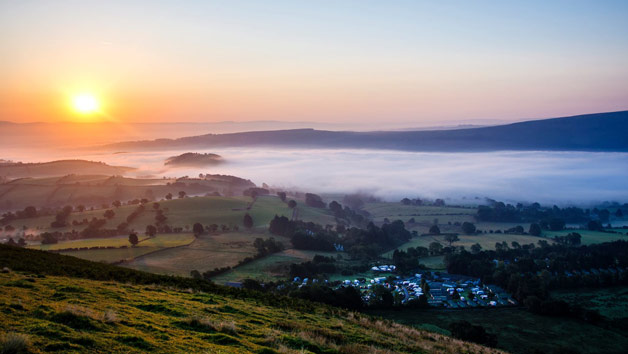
top-left (0, 0), bottom-right (628, 125)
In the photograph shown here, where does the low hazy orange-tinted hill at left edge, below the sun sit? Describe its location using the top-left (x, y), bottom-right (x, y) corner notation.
top-left (0, 160), bottom-right (133, 179)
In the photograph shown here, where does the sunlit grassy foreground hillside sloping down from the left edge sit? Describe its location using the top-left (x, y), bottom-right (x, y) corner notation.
top-left (0, 245), bottom-right (498, 353)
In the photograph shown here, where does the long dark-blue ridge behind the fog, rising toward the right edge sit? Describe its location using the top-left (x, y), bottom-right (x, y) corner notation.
top-left (107, 111), bottom-right (628, 151)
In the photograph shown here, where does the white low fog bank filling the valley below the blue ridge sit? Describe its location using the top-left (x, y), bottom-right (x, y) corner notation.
top-left (4, 149), bottom-right (628, 205)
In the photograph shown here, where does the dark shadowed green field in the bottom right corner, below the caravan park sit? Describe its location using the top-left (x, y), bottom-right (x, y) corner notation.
top-left (371, 306), bottom-right (628, 354)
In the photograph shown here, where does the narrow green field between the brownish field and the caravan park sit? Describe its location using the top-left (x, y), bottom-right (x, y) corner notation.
top-left (212, 249), bottom-right (336, 284)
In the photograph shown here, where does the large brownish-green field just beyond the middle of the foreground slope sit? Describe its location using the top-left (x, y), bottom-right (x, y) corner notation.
top-left (124, 231), bottom-right (288, 276)
